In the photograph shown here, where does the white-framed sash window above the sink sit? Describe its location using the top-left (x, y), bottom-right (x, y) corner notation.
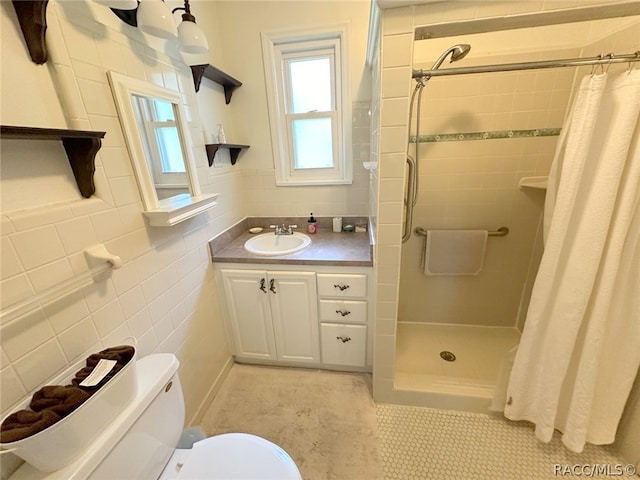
top-left (262, 28), bottom-right (352, 185)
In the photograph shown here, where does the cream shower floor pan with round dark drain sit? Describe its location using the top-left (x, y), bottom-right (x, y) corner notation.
top-left (394, 322), bottom-right (520, 412)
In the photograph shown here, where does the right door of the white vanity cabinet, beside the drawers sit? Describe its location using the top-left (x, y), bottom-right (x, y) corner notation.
top-left (267, 271), bottom-right (320, 363)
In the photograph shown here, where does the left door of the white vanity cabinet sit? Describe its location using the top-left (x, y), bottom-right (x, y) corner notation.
top-left (220, 269), bottom-right (277, 360)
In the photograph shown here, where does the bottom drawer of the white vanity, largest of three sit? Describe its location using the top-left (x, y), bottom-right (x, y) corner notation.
top-left (320, 323), bottom-right (367, 367)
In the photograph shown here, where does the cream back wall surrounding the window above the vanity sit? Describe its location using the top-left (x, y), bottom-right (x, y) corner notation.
top-left (208, 1), bottom-right (371, 216)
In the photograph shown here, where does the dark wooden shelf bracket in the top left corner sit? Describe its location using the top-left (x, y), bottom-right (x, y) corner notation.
top-left (12, 0), bottom-right (49, 65)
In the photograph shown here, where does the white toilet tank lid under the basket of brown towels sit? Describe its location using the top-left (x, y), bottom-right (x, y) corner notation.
top-left (10, 353), bottom-right (180, 480)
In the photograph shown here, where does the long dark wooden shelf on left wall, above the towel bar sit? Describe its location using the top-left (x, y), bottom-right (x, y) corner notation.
top-left (0, 125), bottom-right (105, 198)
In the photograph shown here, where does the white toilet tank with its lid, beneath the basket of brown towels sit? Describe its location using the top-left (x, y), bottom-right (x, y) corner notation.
top-left (11, 353), bottom-right (185, 480)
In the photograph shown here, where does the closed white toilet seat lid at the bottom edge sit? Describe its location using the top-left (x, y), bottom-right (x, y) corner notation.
top-left (162, 433), bottom-right (302, 480)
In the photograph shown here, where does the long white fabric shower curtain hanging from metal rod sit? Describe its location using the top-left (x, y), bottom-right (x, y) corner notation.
top-left (505, 70), bottom-right (640, 452)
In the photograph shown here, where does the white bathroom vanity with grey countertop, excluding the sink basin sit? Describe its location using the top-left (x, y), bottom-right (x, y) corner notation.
top-left (211, 219), bottom-right (374, 371)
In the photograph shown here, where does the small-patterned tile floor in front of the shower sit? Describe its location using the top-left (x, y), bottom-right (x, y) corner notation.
top-left (377, 404), bottom-right (637, 480)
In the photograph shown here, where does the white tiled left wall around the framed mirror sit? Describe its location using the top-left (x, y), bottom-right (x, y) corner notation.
top-left (0, 1), bottom-right (238, 469)
